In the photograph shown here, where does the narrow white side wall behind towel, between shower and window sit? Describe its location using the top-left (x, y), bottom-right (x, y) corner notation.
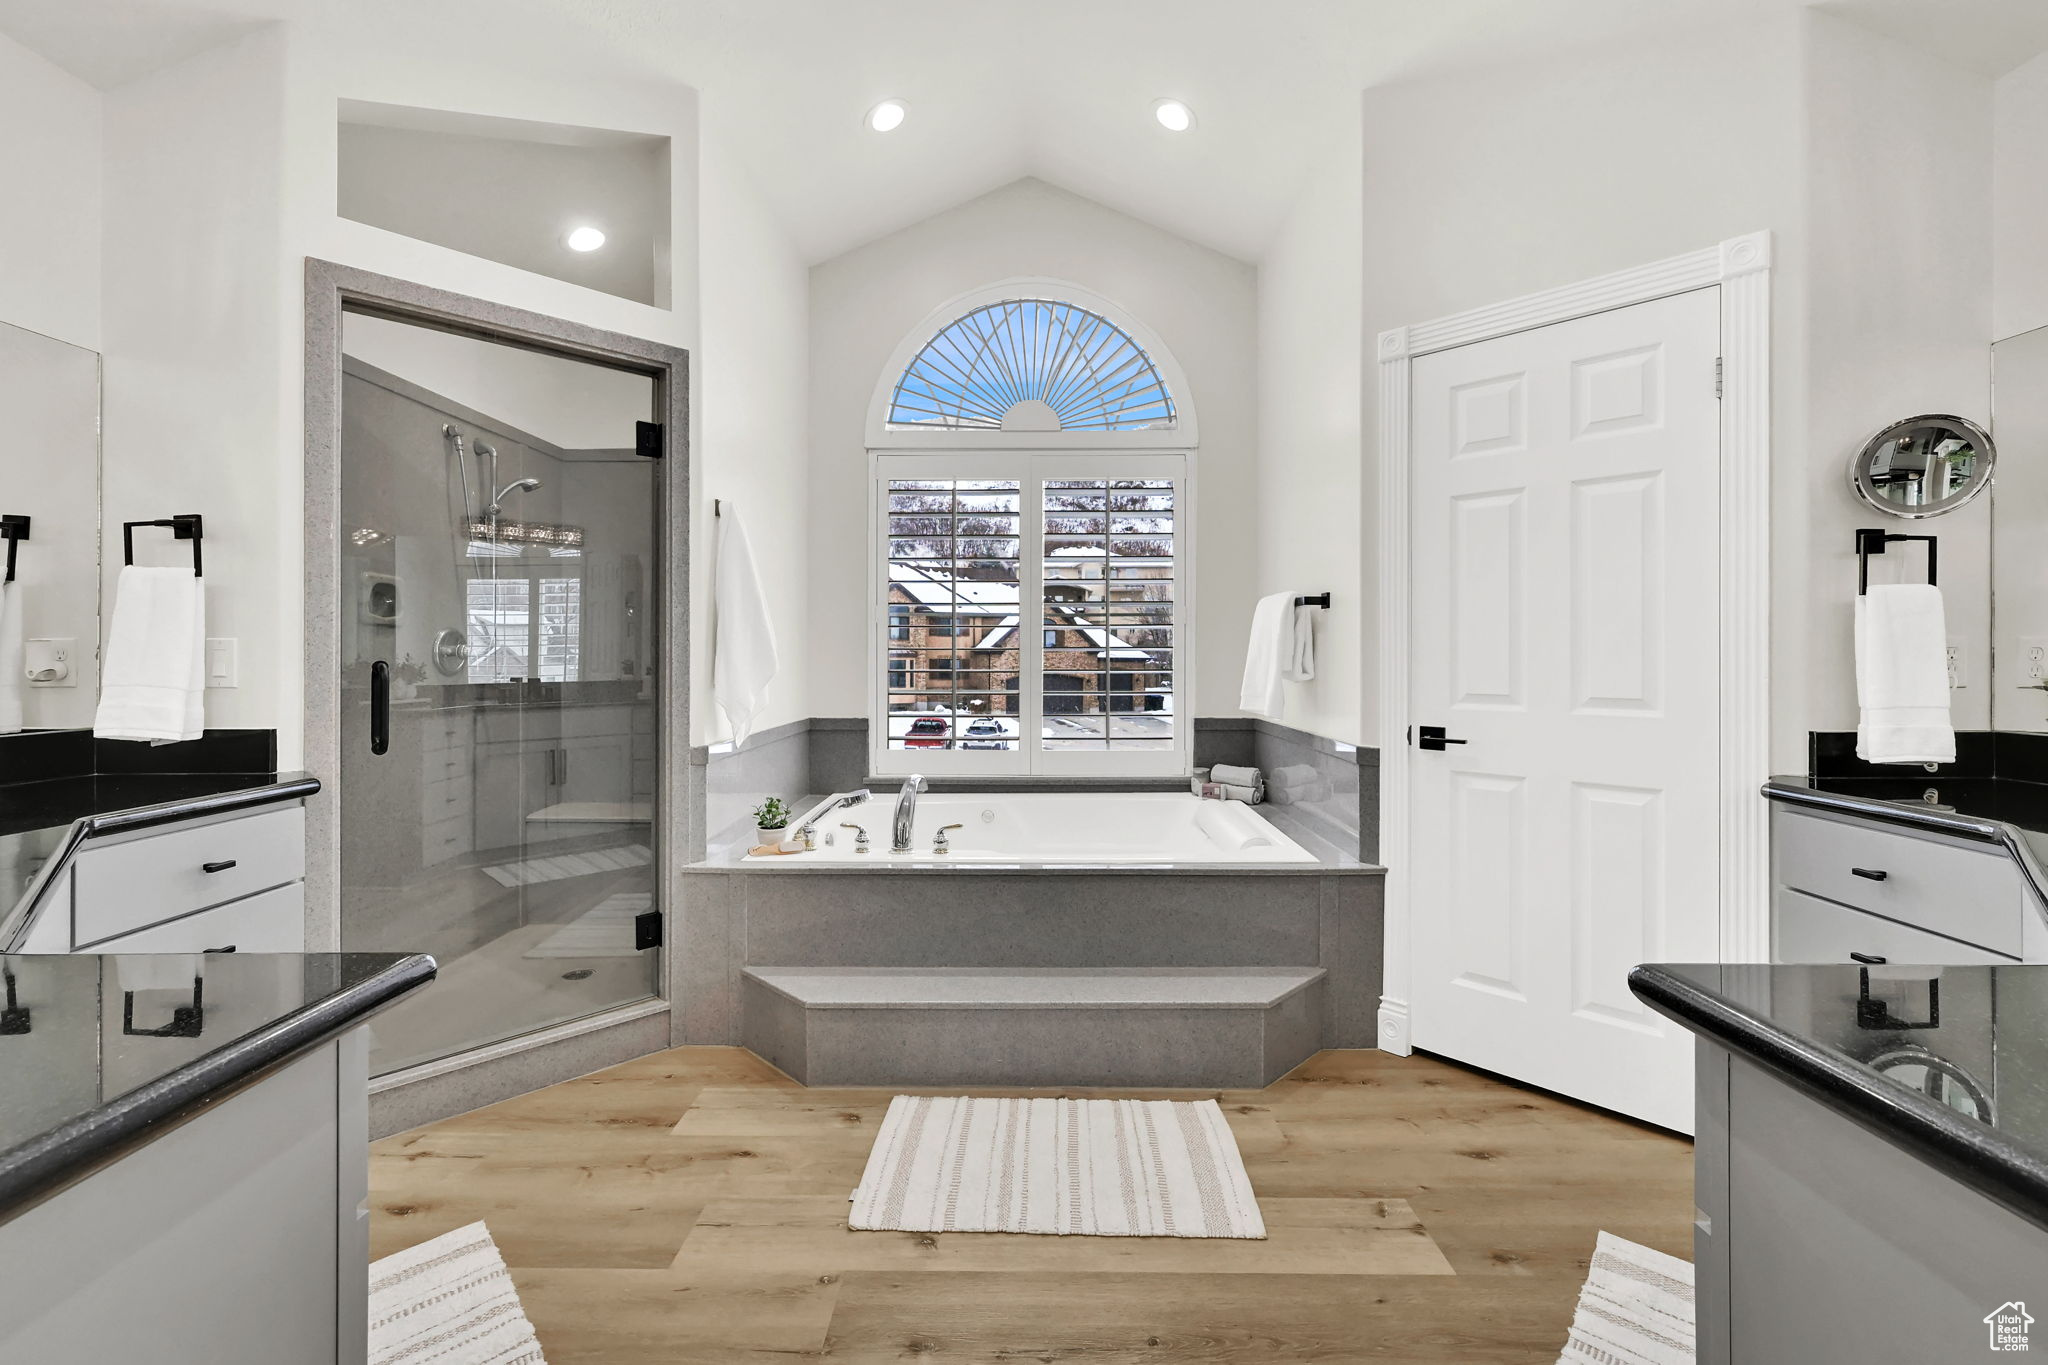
top-left (694, 119), bottom-right (806, 741)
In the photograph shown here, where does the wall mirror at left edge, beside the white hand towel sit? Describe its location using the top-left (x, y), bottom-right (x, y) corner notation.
top-left (0, 323), bottom-right (100, 733)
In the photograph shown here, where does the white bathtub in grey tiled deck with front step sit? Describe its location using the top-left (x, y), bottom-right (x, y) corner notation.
top-left (676, 792), bottom-right (1384, 1087)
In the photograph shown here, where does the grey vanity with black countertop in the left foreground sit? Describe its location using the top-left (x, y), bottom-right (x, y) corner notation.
top-left (0, 952), bottom-right (434, 1365)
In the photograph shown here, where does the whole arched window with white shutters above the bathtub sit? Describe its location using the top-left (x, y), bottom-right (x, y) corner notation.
top-left (868, 280), bottom-right (1196, 778)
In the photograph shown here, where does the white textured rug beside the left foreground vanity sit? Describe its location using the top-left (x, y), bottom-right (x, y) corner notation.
top-left (369, 1224), bottom-right (547, 1365)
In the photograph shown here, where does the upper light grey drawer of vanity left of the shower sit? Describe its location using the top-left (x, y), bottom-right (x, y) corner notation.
top-left (72, 806), bottom-right (305, 948)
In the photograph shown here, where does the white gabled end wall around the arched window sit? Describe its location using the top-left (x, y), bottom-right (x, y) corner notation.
top-left (809, 180), bottom-right (1260, 716)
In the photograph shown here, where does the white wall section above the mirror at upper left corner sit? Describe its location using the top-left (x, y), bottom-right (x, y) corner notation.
top-left (0, 33), bottom-right (100, 350)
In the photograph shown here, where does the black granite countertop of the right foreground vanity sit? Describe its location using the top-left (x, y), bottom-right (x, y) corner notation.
top-left (1628, 964), bottom-right (2048, 1228)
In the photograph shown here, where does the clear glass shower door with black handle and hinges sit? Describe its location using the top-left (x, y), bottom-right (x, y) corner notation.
top-left (340, 313), bottom-right (662, 1074)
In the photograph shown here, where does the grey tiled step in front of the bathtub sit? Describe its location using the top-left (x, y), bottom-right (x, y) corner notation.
top-left (741, 966), bottom-right (1323, 1089)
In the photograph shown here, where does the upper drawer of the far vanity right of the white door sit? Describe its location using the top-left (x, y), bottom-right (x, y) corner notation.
top-left (1774, 810), bottom-right (2030, 958)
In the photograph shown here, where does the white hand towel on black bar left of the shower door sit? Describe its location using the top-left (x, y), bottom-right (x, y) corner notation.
top-left (92, 565), bottom-right (207, 745)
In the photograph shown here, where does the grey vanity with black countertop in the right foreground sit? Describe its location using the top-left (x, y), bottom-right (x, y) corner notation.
top-left (1630, 964), bottom-right (2048, 1365)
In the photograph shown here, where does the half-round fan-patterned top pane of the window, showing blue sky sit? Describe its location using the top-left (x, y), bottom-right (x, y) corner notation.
top-left (889, 299), bottom-right (1174, 432)
